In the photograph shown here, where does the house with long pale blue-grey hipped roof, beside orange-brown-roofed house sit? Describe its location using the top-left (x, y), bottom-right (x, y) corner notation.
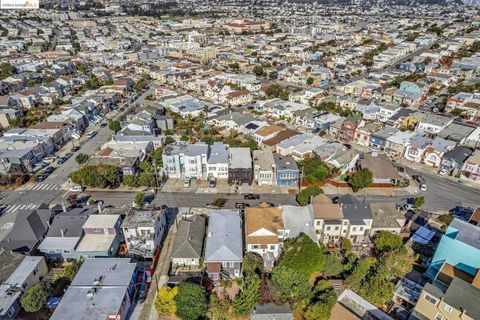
top-left (205, 210), bottom-right (243, 280)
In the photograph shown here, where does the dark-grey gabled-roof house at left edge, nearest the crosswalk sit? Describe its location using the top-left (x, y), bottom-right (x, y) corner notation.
top-left (0, 208), bottom-right (54, 255)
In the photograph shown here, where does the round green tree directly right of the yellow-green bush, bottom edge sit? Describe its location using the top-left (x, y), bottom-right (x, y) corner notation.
top-left (175, 282), bottom-right (207, 320)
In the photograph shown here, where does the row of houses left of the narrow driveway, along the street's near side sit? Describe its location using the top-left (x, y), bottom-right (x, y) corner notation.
top-left (0, 205), bottom-right (174, 261)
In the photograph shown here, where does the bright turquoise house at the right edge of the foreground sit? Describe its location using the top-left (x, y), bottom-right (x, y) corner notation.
top-left (426, 219), bottom-right (480, 279)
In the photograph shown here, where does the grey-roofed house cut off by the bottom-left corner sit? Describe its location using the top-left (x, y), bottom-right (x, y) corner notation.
top-left (0, 257), bottom-right (48, 320)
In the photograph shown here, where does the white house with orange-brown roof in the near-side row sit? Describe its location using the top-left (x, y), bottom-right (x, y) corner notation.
top-left (245, 208), bottom-right (289, 268)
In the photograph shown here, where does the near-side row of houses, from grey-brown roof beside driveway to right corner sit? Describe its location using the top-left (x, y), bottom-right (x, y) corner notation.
top-left (171, 195), bottom-right (406, 280)
